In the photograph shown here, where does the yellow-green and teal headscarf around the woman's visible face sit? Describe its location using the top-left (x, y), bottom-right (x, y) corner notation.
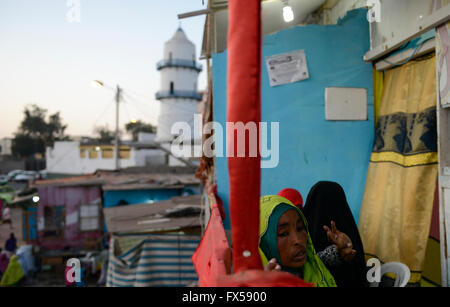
top-left (259, 195), bottom-right (336, 287)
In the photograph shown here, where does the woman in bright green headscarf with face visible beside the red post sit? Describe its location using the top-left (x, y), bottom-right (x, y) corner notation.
top-left (259, 195), bottom-right (336, 287)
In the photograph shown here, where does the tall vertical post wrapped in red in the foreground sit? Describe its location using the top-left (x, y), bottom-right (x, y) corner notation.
top-left (227, 0), bottom-right (262, 273)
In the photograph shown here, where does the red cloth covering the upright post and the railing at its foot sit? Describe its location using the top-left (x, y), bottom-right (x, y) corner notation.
top-left (192, 0), bottom-right (313, 287)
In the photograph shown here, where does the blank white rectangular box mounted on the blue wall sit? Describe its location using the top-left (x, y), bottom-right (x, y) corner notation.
top-left (325, 87), bottom-right (367, 120)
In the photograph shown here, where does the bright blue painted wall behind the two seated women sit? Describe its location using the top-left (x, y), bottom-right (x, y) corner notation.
top-left (213, 9), bottom-right (374, 229)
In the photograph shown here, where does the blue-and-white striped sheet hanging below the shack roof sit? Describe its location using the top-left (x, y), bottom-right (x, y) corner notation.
top-left (106, 234), bottom-right (200, 287)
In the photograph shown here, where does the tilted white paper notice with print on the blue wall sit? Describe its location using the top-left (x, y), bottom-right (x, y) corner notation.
top-left (266, 50), bottom-right (309, 86)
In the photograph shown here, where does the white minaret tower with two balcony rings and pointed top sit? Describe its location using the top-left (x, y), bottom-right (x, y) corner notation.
top-left (156, 27), bottom-right (202, 143)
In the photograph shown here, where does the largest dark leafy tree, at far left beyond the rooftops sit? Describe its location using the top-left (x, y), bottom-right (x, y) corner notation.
top-left (12, 104), bottom-right (69, 158)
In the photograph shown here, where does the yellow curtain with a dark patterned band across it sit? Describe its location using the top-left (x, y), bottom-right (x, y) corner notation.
top-left (359, 56), bottom-right (438, 283)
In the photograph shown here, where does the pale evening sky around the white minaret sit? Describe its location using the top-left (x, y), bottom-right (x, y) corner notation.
top-left (0, 0), bottom-right (207, 138)
